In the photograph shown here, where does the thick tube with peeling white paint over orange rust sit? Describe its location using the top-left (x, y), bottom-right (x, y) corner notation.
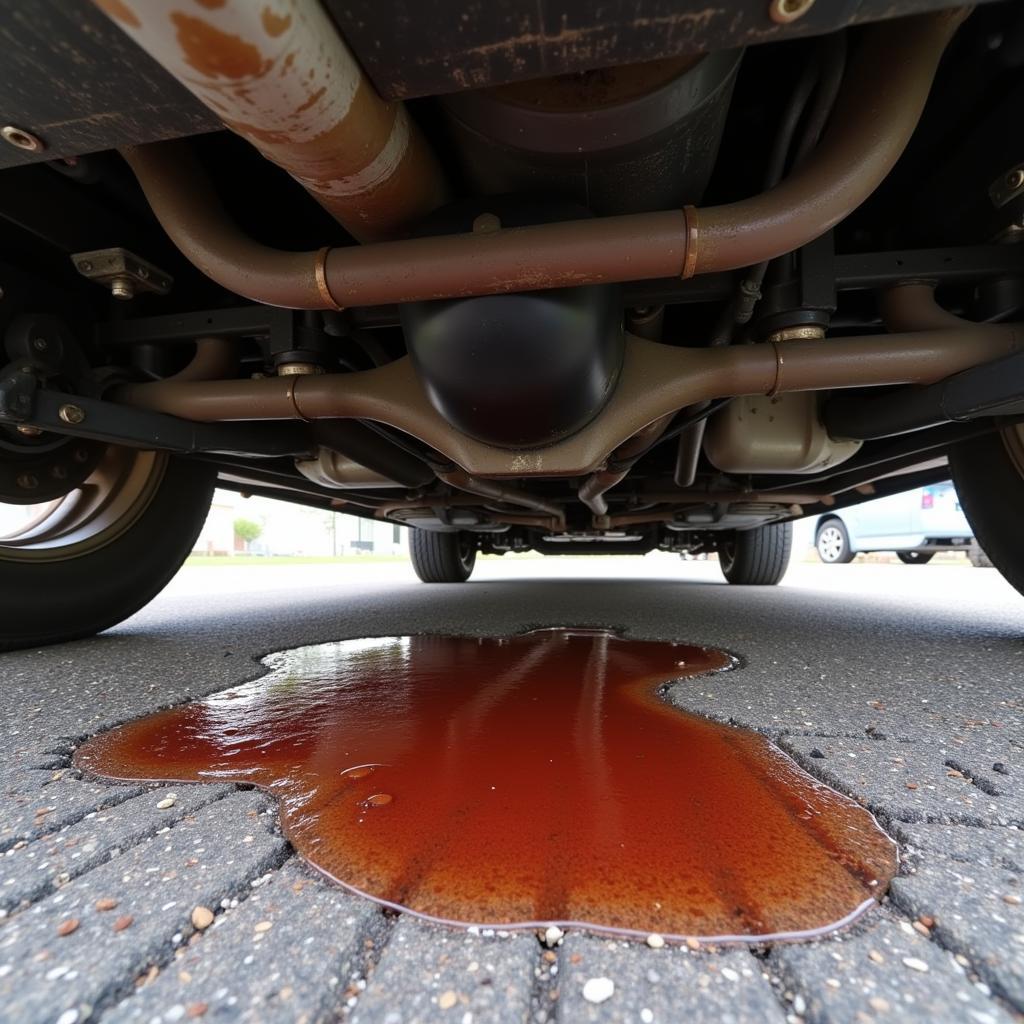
top-left (95, 0), bottom-right (444, 242)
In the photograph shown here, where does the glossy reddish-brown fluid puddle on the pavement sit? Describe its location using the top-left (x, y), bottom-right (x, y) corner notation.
top-left (76, 629), bottom-right (897, 941)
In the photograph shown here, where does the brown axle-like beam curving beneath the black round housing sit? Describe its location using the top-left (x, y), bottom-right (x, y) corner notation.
top-left (112, 324), bottom-right (1024, 477)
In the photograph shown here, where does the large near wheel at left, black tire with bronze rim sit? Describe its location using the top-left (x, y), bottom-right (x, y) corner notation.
top-left (0, 444), bottom-right (215, 650)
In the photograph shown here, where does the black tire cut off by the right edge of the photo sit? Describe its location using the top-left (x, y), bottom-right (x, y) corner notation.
top-left (949, 426), bottom-right (1024, 594)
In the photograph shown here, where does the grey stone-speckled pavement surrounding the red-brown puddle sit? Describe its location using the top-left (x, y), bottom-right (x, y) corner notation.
top-left (0, 556), bottom-right (1024, 1024)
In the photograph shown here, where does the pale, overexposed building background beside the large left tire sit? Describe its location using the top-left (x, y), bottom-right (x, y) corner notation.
top-left (194, 490), bottom-right (408, 558)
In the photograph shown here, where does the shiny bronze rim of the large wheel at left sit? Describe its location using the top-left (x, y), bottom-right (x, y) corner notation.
top-left (0, 446), bottom-right (168, 562)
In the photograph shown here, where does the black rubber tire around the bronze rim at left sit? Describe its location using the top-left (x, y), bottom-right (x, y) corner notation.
top-left (0, 458), bottom-right (215, 650)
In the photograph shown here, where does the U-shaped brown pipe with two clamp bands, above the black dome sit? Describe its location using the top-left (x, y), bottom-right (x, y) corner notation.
top-left (117, 9), bottom-right (967, 309)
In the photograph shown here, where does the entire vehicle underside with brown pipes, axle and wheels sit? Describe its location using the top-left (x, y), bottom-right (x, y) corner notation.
top-left (0, 0), bottom-right (1024, 646)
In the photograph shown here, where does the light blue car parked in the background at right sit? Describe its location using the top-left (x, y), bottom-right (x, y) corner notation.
top-left (814, 481), bottom-right (987, 565)
